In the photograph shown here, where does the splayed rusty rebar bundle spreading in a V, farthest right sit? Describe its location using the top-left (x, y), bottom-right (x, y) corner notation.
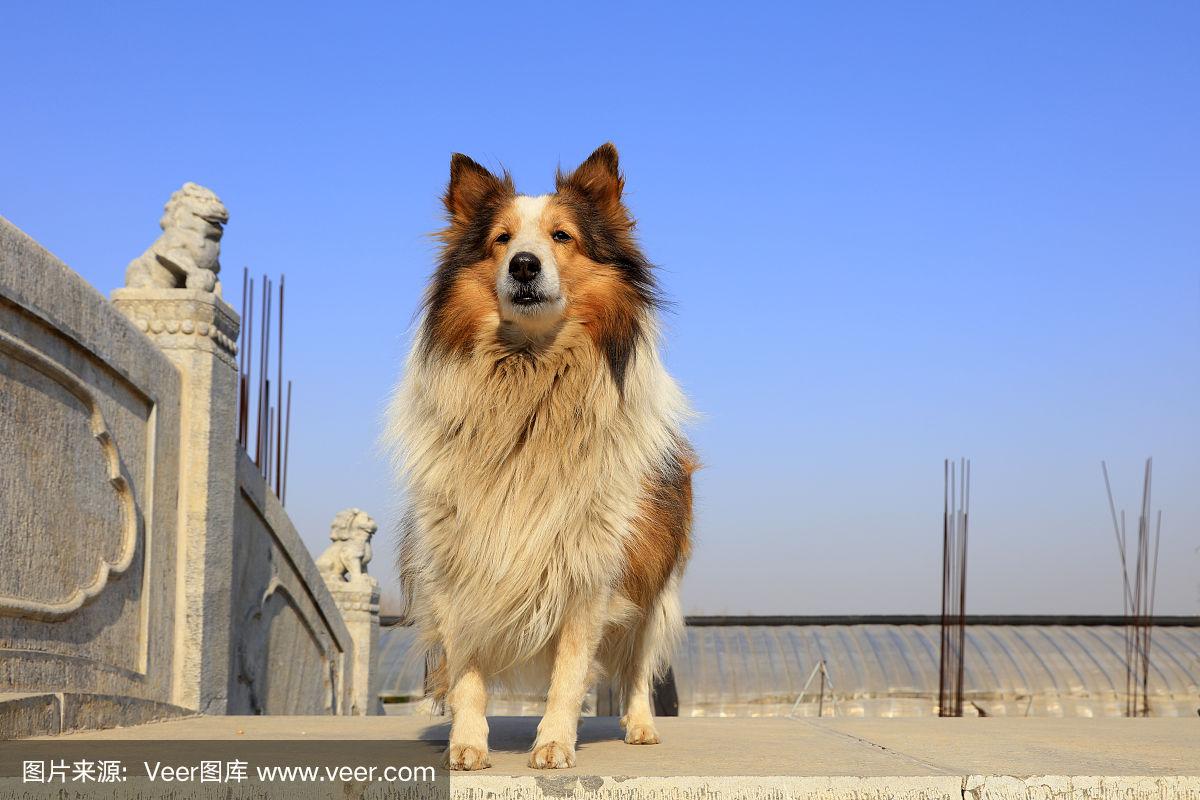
top-left (1100, 458), bottom-right (1163, 717)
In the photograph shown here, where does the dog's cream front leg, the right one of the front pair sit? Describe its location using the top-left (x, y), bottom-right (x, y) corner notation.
top-left (529, 599), bottom-right (607, 769)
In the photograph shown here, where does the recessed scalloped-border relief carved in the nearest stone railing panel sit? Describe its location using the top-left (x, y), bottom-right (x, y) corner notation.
top-left (0, 331), bottom-right (140, 620)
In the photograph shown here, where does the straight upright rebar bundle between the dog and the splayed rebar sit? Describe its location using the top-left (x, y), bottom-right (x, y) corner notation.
top-left (937, 458), bottom-right (971, 717)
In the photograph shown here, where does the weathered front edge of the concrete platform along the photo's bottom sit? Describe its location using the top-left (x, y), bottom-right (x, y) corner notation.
top-left (450, 775), bottom-right (1200, 800)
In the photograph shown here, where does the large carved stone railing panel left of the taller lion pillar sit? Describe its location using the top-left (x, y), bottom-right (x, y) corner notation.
top-left (0, 214), bottom-right (181, 703)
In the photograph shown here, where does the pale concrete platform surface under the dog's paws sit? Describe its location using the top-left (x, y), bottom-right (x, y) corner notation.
top-left (39, 717), bottom-right (1200, 800)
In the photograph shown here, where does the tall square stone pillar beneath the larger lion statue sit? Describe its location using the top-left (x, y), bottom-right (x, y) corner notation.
top-left (113, 287), bottom-right (241, 714)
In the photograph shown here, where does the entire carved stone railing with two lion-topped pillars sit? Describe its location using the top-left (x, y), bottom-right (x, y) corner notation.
top-left (0, 190), bottom-right (378, 735)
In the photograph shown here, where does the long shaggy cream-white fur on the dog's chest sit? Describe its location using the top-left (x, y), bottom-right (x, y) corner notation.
top-left (388, 321), bottom-right (686, 668)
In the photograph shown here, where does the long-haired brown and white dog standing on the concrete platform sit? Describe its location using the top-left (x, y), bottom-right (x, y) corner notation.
top-left (385, 144), bottom-right (695, 770)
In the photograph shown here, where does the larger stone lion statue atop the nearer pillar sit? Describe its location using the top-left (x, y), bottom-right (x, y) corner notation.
top-left (125, 182), bottom-right (229, 295)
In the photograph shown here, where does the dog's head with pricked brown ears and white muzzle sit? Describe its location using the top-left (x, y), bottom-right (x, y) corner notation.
top-left (426, 144), bottom-right (654, 381)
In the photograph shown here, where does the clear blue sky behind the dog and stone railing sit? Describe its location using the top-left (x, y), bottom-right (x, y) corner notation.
top-left (0, 2), bottom-right (1200, 613)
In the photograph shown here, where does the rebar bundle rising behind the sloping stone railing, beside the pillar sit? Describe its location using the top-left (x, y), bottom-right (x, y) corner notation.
top-left (238, 267), bottom-right (292, 503)
